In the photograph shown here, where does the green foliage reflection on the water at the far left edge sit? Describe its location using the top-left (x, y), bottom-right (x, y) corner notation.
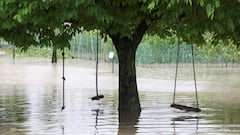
top-left (0, 86), bottom-right (30, 135)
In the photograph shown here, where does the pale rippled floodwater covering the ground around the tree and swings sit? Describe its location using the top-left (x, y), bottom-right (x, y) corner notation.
top-left (0, 57), bottom-right (240, 135)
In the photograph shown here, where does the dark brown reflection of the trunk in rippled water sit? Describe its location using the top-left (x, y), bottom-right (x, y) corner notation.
top-left (118, 111), bottom-right (140, 135)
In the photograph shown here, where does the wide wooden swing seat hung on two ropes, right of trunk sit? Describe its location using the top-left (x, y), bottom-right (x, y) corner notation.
top-left (170, 38), bottom-right (201, 112)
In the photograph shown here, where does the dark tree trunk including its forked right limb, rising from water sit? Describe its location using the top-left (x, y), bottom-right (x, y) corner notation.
top-left (110, 21), bottom-right (147, 112)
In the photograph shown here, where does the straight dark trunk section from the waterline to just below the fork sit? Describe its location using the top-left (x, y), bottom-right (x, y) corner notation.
top-left (115, 41), bottom-right (141, 111)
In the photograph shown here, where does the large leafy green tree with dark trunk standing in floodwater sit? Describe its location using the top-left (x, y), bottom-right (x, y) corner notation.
top-left (0, 0), bottom-right (240, 111)
